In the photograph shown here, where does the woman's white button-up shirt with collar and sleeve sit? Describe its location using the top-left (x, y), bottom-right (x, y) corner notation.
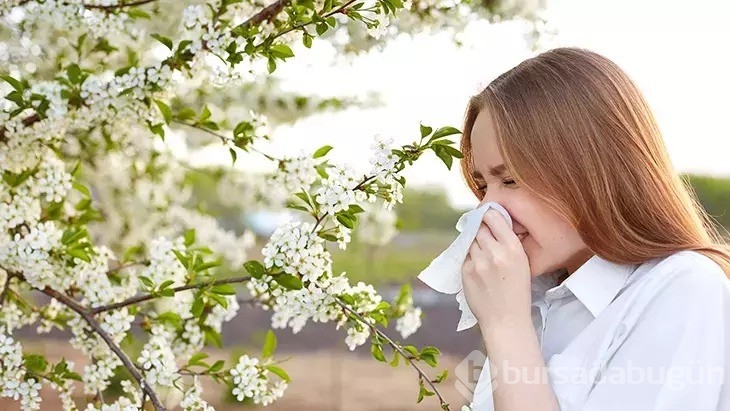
top-left (472, 251), bottom-right (730, 411)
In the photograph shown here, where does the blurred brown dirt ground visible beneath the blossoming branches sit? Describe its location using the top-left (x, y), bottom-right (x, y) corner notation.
top-left (0, 342), bottom-right (466, 411)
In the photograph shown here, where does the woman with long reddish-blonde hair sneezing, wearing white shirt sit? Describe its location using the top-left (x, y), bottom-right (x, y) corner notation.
top-left (461, 48), bottom-right (730, 411)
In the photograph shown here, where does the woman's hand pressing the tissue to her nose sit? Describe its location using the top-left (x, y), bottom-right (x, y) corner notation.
top-left (461, 209), bottom-right (531, 330)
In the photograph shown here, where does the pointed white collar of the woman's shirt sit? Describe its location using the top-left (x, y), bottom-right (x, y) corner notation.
top-left (532, 254), bottom-right (638, 317)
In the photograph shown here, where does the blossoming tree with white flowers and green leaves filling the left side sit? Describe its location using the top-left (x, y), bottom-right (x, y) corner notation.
top-left (0, 0), bottom-right (540, 411)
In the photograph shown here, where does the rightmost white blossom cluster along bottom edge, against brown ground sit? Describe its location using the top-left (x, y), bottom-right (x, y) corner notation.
top-left (230, 355), bottom-right (287, 406)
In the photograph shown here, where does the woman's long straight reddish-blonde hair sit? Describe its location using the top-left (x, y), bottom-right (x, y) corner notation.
top-left (461, 48), bottom-right (730, 276)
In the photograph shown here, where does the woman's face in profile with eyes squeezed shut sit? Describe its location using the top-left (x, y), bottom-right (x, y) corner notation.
top-left (471, 110), bottom-right (592, 276)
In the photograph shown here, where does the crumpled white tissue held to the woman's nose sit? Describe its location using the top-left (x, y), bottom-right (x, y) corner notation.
top-left (418, 201), bottom-right (512, 331)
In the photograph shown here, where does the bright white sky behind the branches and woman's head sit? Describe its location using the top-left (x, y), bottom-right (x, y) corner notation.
top-left (189, 0), bottom-right (730, 208)
